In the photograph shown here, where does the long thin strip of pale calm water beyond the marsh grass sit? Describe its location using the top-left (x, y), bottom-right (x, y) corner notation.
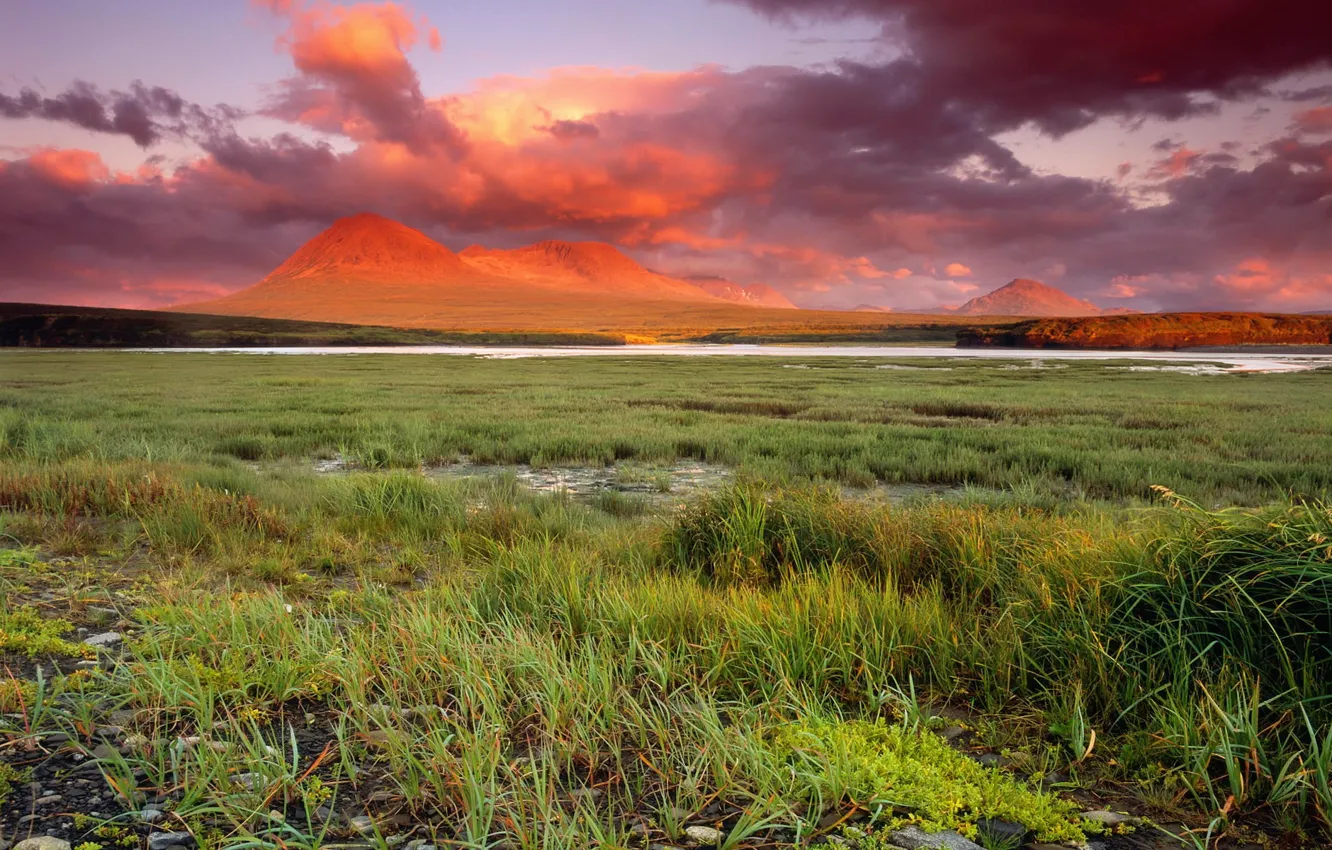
top-left (131, 344), bottom-right (1332, 374)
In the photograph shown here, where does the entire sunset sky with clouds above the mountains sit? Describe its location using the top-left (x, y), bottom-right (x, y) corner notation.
top-left (0, 0), bottom-right (1332, 312)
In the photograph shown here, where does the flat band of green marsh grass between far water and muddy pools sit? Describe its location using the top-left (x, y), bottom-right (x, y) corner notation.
top-left (0, 352), bottom-right (1332, 506)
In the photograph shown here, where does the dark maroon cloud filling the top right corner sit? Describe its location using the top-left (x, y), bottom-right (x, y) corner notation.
top-left (729, 0), bottom-right (1332, 135)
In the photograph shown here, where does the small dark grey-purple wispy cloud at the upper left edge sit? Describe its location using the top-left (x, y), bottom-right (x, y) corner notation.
top-left (0, 80), bottom-right (242, 148)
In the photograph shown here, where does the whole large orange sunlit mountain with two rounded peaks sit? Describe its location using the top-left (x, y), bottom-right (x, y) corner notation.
top-left (172, 213), bottom-right (825, 330)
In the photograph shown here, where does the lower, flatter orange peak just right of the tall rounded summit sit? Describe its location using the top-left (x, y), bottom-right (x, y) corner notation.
top-left (462, 240), bottom-right (711, 301)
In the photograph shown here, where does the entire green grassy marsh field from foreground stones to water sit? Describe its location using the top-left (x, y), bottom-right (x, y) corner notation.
top-left (0, 352), bottom-right (1332, 850)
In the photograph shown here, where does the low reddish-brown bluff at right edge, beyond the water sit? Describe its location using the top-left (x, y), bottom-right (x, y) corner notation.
top-left (958, 313), bottom-right (1332, 349)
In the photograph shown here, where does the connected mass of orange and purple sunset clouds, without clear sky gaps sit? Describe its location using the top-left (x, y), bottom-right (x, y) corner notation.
top-left (0, 0), bottom-right (1332, 309)
